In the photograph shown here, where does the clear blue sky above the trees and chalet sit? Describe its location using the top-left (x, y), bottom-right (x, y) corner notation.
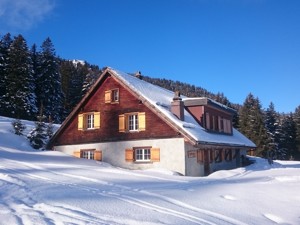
top-left (0, 0), bottom-right (300, 112)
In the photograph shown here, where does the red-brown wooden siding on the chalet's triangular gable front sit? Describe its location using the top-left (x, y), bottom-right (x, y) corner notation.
top-left (53, 76), bottom-right (178, 145)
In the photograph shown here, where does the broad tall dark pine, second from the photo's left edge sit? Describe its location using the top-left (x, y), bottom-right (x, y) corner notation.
top-left (5, 35), bottom-right (37, 119)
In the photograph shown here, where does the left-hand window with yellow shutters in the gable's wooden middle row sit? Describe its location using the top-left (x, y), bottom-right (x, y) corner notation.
top-left (78, 112), bottom-right (100, 130)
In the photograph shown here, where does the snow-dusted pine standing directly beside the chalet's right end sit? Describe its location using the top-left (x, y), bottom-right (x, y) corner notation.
top-left (239, 93), bottom-right (268, 156)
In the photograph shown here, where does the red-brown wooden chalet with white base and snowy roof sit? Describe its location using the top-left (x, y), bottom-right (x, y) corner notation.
top-left (48, 68), bottom-right (256, 176)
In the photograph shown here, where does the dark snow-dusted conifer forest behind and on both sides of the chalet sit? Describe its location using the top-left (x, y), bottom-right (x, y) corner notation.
top-left (0, 33), bottom-right (300, 160)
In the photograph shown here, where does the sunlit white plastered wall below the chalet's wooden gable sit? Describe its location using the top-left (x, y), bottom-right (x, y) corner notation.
top-left (54, 138), bottom-right (189, 175)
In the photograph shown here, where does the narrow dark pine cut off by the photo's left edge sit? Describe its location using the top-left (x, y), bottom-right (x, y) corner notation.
top-left (0, 33), bottom-right (12, 116)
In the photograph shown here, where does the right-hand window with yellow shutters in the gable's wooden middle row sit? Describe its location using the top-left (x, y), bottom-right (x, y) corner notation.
top-left (119, 112), bottom-right (146, 132)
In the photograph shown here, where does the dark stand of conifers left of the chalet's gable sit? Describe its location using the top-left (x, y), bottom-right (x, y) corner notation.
top-left (0, 33), bottom-right (101, 123)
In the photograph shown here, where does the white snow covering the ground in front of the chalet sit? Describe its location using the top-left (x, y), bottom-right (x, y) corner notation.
top-left (0, 117), bottom-right (300, 225)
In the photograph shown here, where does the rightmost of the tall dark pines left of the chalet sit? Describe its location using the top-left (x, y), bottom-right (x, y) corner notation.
top-left (36, 38), bottom-right (64, 123)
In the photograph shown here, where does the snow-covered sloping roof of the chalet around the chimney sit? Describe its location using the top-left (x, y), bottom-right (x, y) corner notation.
top-left (109, 68), bottom-right (256, 148)
